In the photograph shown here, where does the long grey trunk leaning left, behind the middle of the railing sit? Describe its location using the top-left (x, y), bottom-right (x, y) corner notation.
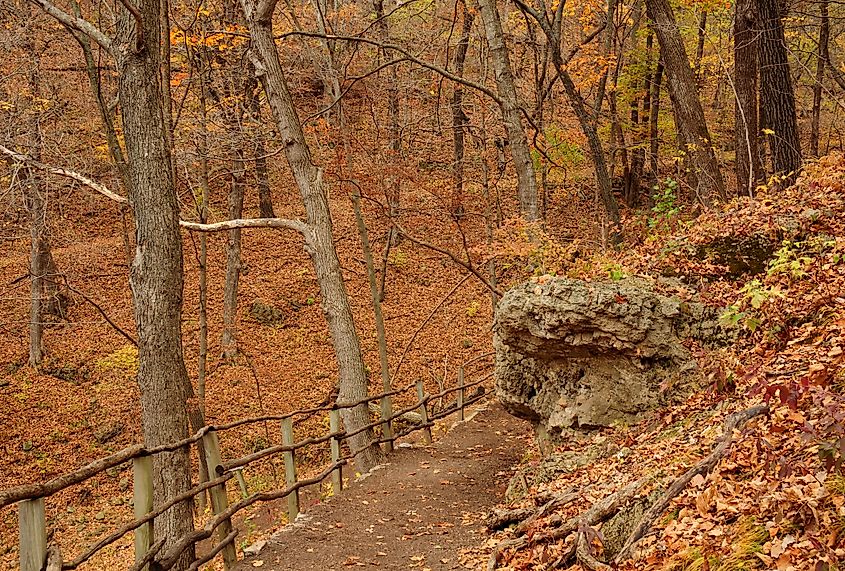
top-left (242, 5), bottom-right (384, 471)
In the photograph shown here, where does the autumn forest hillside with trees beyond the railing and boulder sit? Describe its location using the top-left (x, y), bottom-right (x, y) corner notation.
top-left (0, 0), bottom-right (845, 566)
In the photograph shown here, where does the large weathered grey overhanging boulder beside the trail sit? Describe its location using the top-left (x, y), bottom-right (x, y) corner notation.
top-left (494, 278), bottom-right (727, 437)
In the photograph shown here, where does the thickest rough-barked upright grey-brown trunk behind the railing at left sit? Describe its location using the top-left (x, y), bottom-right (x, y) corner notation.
top-left (114, 0), bottom-right (194, 569)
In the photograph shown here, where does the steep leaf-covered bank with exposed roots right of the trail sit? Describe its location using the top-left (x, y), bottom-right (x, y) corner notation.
top-left (473, 155), bottom-right (845, 571)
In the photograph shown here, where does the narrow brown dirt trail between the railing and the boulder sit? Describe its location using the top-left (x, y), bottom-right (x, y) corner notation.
top-left (236, 401), bottom-right (530, 571)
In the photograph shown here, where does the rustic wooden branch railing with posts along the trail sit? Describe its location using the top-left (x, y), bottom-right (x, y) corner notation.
top-left (0, 353), bottom-right (492, 571)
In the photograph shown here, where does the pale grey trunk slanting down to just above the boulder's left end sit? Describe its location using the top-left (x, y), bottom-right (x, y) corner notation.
top-left (478, 0), bottom-right (540, 222)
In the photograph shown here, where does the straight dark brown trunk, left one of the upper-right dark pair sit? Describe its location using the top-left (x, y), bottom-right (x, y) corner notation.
top-left (734, 0), bottom-right (762, 196)
